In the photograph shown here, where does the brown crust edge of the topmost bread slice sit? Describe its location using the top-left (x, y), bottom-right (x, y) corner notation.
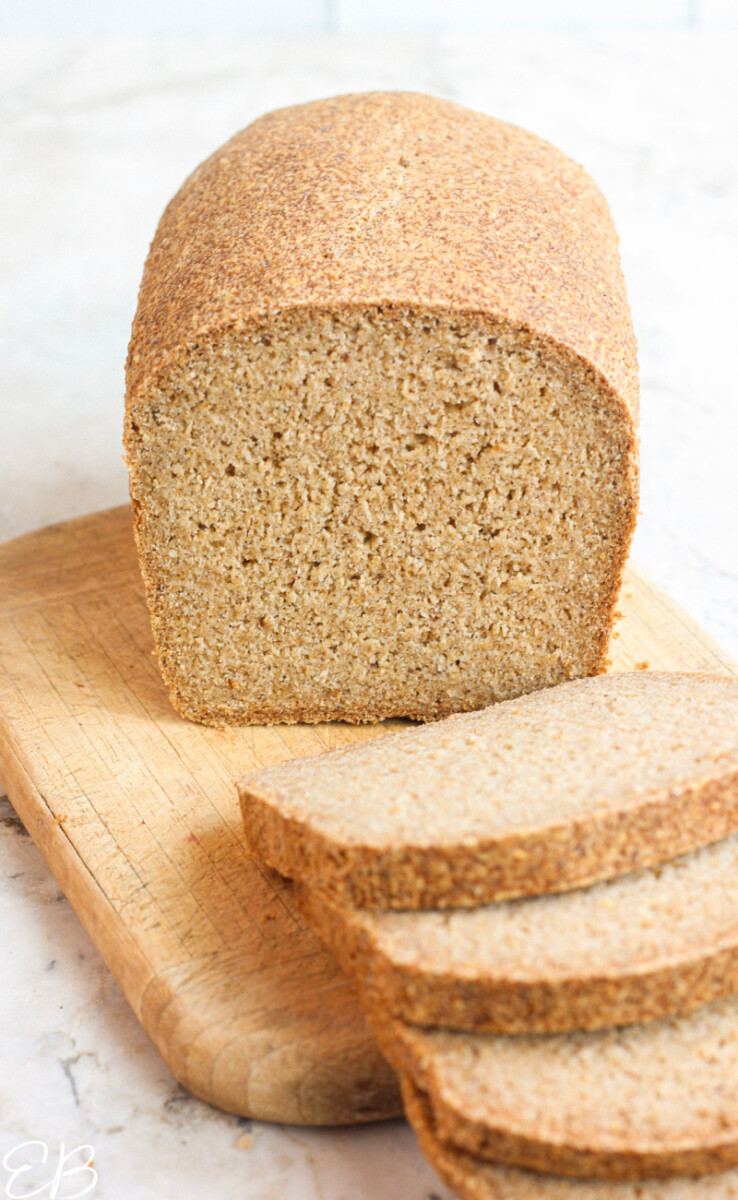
top-left (239, 766), bottom-right (738, 908)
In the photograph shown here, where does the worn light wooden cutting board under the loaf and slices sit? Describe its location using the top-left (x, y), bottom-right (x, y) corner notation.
top-left (0, 508), bottom-right (738, 1124)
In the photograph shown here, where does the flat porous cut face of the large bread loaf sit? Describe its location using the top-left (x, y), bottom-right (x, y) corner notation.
top-left (128, 308), bottom-right (631, 721)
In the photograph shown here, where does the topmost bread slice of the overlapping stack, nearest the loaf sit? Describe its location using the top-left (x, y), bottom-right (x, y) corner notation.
top-left (239, 672), bottom-right (738, 908)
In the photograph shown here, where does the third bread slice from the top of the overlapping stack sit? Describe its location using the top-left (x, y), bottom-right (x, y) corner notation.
top-left (370, 997), bottom-right (738, 1178)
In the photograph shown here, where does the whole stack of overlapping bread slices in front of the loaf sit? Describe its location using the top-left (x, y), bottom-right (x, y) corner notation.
top-left (240, 672), bottom-right (738, 1200)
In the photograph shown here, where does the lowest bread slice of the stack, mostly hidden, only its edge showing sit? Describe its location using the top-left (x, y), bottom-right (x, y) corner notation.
top-left (400, 1076), bottom-right (738, 1200)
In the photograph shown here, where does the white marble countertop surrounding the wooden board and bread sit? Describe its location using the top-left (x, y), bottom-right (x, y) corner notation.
top-left (0, 31), bottom-right (738, 1200)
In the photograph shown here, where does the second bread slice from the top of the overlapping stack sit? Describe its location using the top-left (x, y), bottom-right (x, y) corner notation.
top-left (295, 834), bottom-right (738, 1033)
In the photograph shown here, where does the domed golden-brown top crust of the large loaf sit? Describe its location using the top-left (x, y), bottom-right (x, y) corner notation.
top-left (127, 92), bottom-right (638, 421)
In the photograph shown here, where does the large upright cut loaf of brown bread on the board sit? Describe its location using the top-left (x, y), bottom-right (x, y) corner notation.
top-left (125, 92), bottom-right (637, 724)
